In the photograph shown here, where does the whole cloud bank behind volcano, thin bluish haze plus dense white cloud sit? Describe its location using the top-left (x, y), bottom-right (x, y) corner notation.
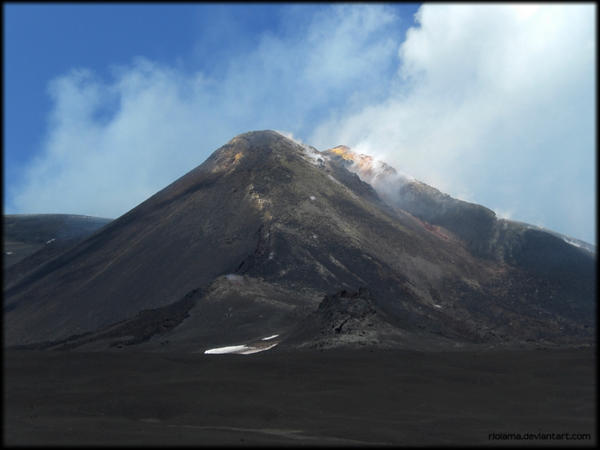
top-left (9, 4), bottom-right (595, 242)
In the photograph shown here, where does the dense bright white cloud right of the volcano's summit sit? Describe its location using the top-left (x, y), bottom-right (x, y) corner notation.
top-left (309, 4), bottom-right (595, 241)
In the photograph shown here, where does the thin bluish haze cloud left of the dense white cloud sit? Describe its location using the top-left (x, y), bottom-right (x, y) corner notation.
top-left (10, 5), bottom-right (397, 217)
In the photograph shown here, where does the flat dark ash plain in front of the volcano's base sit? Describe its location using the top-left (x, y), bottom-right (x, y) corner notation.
top-left (4, 348), bottom-right (596, 446)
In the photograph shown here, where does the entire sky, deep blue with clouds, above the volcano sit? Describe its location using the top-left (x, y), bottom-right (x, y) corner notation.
top-left (4, 3), bottom-right (596, 243)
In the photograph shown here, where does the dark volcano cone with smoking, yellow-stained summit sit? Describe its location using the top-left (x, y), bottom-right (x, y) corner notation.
top-left (4, 131), bottom-right (596, 352)
